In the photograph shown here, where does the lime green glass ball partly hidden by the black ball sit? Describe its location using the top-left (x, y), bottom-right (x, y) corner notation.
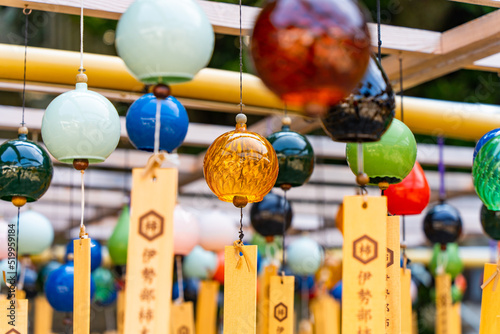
top-left (346, 119), bottom-right (417, 185)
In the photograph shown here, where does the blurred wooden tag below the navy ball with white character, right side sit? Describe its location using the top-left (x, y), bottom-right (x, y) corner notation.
top-left (436, 274), bottom-right (455, 334)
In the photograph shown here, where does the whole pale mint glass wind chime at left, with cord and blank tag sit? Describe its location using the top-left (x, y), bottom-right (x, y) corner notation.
top-left (42, 1), bottom-right (120, 334)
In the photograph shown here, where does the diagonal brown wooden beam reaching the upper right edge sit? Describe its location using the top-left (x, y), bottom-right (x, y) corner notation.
top-left (382, 10), bottom-right (500, 90)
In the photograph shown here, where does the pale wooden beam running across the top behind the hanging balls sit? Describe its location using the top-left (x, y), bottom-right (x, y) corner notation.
top-left (0, 0), bottom-right (441, 53)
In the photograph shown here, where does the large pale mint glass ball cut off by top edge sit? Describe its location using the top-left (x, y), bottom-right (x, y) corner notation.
top-left (116, 0), bottom-right (214, 84)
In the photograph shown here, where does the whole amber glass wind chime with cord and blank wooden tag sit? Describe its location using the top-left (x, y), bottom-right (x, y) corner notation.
top-left (203, 1), bottom-right (278, 334)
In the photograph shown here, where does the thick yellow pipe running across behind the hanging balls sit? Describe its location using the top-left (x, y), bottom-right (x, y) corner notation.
top-left (0, 44), bottom-right (500, 140)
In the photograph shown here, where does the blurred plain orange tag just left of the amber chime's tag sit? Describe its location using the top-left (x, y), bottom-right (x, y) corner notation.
top-left (196, 281), bottom-right (219, 334)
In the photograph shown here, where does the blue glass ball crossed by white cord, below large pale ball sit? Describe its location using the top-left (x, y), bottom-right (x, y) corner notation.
top-left (126, 93), bottom-right (189, 153)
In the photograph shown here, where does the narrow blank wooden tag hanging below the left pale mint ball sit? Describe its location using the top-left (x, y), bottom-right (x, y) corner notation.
top-left (73, 238), bottom-right (91, 334)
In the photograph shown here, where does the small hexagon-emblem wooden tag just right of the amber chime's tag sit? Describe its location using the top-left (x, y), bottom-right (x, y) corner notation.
top-left (269, 276), bottom-right (295, 334)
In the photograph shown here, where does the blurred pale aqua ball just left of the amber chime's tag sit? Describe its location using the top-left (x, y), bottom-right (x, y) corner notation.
top-left (182, 246), bottom-right (217, 279)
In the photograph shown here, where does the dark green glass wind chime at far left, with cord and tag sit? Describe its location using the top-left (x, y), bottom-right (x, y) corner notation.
top-left (0, 6), bottom-right (53, 332)
